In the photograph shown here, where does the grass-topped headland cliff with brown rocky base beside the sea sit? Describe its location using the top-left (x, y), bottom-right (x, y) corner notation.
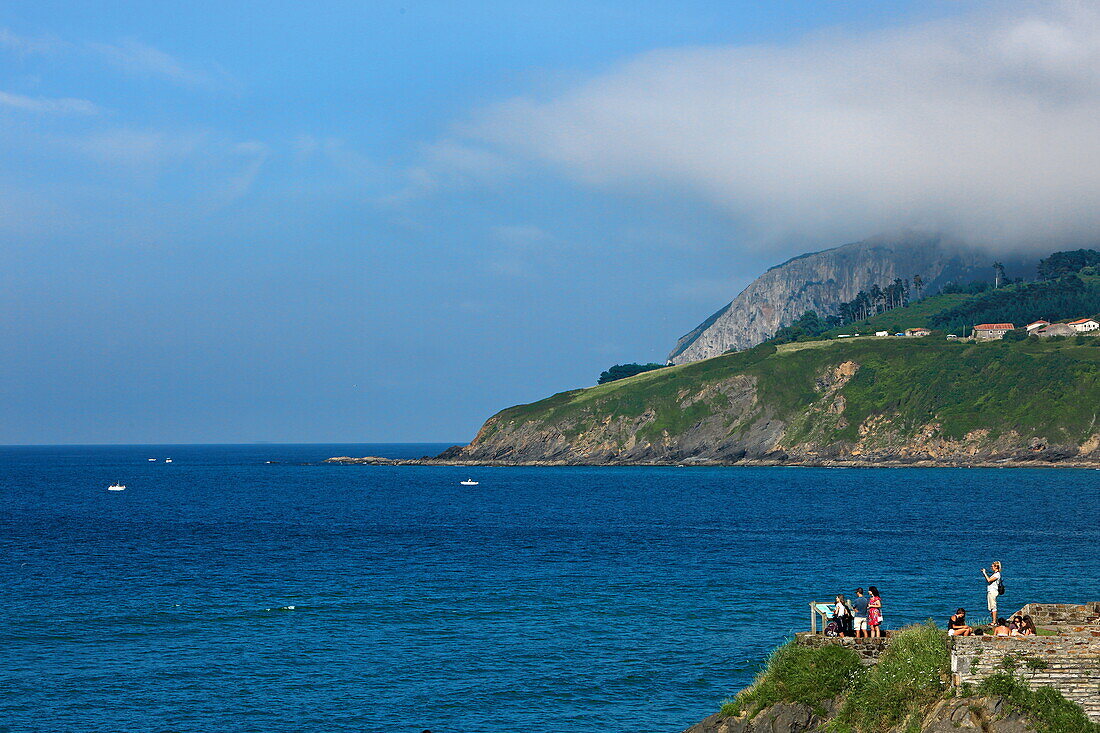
top-left (440, 337), bottom-right (1100, 466)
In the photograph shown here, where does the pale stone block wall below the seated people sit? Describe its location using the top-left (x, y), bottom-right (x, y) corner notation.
top-left (952, 633), bottom-right (1100, 721)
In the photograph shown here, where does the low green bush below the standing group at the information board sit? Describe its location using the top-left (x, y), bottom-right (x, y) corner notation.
top-left (722, 642), bottom-right (864, 716)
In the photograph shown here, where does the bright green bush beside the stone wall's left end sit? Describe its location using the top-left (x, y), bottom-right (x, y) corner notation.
top-left (833, 621), bottom-right (950, 733)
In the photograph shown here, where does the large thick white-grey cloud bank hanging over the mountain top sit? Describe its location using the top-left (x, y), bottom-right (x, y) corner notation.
top-left (444, 2), bottom-right (1100, 247)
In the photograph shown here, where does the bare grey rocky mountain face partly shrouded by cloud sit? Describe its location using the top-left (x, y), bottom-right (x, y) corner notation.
top-left (669, 234), bottom-right (1034, 364)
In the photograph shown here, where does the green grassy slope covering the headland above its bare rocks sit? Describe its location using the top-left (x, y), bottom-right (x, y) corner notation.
top-left (486, 338), bottom-right (1100, 442)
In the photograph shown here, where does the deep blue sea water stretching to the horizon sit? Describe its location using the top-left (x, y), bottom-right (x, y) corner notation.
top-left (0, 445), bottom-right (1100, 733)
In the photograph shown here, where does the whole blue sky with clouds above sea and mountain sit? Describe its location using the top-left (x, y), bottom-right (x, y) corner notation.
top-left (0, 0), bottom-right (1100, 445)
